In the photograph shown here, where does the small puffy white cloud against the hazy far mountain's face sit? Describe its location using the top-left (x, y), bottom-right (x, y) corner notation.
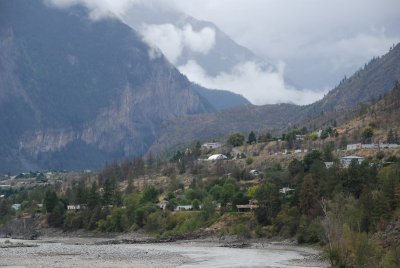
top-left (140, 23), bottom-right (215, 63)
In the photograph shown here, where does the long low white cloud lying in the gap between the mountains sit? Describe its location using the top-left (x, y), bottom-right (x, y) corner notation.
top-left (179, 61), bottom-right (324, 105)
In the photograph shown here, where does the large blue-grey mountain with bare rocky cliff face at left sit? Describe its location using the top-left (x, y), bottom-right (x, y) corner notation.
top-left (0, 0), bottom-right (215, 172)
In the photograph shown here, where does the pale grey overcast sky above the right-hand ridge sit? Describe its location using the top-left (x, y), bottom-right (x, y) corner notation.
top-left (174, 0), bottom-right (400, 89)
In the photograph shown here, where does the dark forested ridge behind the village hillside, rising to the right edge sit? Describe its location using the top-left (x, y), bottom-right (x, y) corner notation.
top-left (150, 44), bottom-right (400, 154)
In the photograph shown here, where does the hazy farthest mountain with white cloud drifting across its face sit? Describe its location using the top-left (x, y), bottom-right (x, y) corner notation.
top-left (122, 2), bottom-right (268, 107)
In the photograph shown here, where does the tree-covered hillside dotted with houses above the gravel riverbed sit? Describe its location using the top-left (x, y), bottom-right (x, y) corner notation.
top-left (0, 83), bottom-right (400, 267)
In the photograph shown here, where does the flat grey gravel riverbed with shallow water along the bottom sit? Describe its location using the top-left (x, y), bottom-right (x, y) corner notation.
top-left (0, 237), bottom-right (328, 268)
